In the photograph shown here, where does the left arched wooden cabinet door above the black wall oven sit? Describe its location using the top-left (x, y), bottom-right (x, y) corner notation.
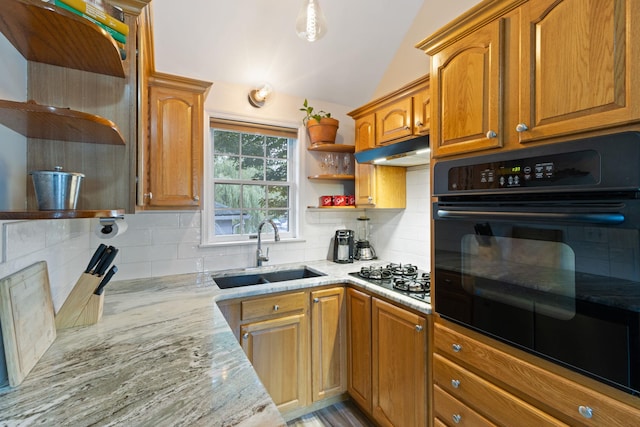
top-left (431, 21), bottom-right (503, 157)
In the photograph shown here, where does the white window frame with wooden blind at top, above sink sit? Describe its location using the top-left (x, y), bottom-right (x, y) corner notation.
top-left (201, 113), bottom-right (304, 246)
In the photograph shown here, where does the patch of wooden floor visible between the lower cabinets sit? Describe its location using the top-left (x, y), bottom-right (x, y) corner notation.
top-left (287, 401), bottom-right (374, 427)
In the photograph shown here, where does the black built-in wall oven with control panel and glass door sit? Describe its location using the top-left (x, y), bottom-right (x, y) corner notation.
top-left (432, 132), bottom-right (640, 395)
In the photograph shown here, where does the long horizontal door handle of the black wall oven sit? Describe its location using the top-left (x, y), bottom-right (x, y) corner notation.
top-left (437, 209), bottom-right (625, 224)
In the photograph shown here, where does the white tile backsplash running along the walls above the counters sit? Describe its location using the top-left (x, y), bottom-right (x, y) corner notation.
top-left (0, 166), bottom-right (430, 311)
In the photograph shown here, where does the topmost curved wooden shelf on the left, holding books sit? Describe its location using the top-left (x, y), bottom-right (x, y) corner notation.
top-left (0, 0), bottom-right (125, 77)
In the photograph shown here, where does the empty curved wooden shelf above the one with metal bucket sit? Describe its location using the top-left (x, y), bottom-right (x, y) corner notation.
top-left (0, 100), bottom-right (125, 145)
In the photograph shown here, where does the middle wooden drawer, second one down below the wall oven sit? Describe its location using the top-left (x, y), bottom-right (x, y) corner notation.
top-left (433, 354), bottom-right (566, 426)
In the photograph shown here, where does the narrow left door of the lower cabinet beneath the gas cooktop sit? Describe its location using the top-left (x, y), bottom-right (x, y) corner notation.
top-left (347, 288), bottom-right (371, 414)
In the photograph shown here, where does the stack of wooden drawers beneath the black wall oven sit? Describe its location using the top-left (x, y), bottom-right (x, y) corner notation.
top-left (433, 318), bottom-right (640, 427)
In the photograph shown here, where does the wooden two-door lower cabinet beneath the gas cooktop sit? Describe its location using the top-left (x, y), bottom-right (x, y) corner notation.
top-left (347, 288), bottom-right (428, 427)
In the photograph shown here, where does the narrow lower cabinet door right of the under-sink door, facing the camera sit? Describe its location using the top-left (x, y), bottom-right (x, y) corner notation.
top-left (311, 287), bottom-right (347, 402)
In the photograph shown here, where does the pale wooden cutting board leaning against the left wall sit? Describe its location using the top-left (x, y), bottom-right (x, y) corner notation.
top-left (0, 261), bottom-right (56, 387)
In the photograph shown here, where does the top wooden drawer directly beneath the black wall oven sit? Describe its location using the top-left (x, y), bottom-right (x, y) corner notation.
top-left (434, 322), bottom-right (640, 427)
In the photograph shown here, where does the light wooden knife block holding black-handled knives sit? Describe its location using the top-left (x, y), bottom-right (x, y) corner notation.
top-left (55, 273), bottom-right (104, 330)
